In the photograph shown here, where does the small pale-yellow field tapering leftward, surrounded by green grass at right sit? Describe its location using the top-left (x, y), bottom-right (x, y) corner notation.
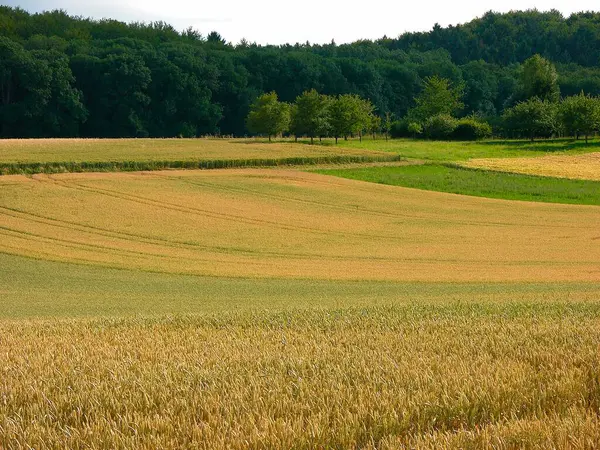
top-left (462, 152), bottom-right (600, 180)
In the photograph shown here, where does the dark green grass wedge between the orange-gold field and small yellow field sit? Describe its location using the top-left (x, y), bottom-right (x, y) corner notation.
top-left (317, 164), bottom-right (600, 205)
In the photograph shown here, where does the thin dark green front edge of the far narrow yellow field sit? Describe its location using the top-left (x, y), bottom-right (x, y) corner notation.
top-left (0, 154), bottom-right (403, 175)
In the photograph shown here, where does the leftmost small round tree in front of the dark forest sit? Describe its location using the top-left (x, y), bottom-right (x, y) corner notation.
top-left (247, 92), bottom-right (290, 142)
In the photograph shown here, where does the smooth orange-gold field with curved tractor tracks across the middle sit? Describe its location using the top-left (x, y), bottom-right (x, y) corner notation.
top-left (0, 169), bottom-right (600, 282)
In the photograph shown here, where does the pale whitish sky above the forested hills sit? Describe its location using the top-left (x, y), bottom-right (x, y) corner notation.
top-left (2, 0), bottom-right (600, 44)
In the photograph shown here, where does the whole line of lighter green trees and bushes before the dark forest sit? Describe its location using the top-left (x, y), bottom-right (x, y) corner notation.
top-left (247, 55), bottom-right (600, 144)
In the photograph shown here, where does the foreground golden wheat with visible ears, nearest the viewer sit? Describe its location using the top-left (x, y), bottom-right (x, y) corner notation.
top-left (0, 308), bottom-right (600, 449)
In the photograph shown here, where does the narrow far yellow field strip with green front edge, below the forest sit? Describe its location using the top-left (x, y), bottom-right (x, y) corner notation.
top-left (0, 139), bottom-right (399, 175)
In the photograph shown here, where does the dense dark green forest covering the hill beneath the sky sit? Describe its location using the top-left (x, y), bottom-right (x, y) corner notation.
top-left (0, 6), bottom-right (600, 137)
